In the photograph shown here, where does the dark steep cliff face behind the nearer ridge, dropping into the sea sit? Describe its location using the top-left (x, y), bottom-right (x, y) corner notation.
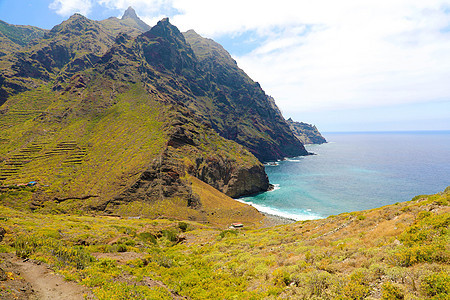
top-left (184, 30), bottom-right (308, 161)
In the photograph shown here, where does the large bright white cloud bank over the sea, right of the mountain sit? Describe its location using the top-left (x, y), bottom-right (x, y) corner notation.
top-left (232, 1), bottom-right (450, 111)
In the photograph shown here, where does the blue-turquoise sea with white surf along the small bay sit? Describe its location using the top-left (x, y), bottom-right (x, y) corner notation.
top-left (239, 131), bottom-right (450, 220)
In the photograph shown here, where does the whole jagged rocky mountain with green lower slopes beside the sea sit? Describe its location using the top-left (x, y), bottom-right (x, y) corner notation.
top-left (0, 9), bottom-right (308, 223)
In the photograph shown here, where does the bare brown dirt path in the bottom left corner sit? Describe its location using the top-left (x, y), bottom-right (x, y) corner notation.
top-left (0, 254), bottom-right (95, 300)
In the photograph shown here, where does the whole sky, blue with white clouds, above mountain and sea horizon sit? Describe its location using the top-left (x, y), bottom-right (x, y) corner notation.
top-left (0, 0), bottom-right (450, 132)
